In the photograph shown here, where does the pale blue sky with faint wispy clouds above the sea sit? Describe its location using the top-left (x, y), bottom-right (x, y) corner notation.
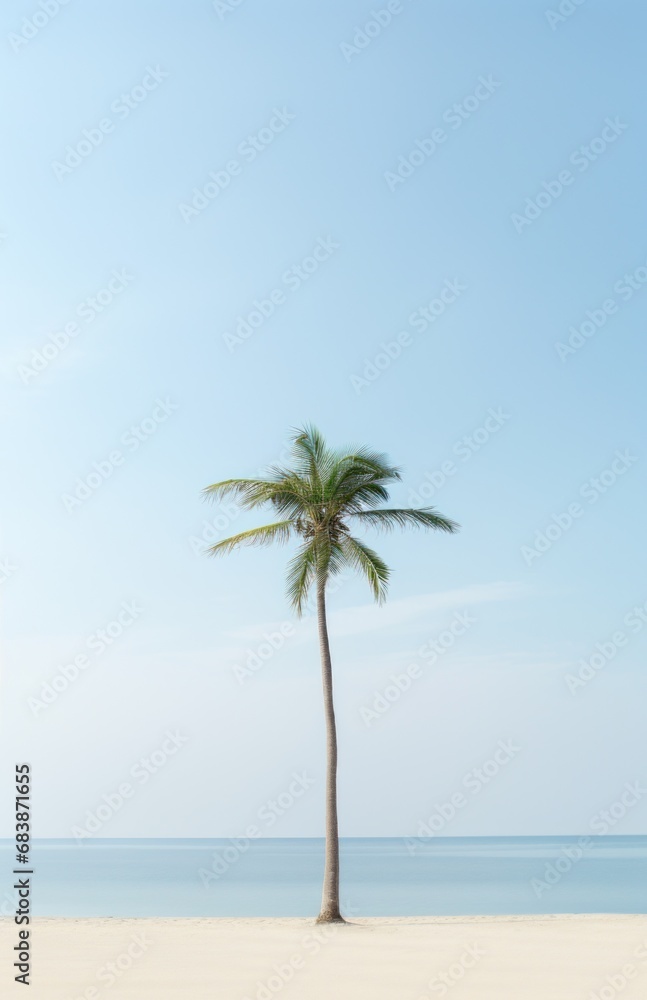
top-left (0, 0), bottom-right (647, 837)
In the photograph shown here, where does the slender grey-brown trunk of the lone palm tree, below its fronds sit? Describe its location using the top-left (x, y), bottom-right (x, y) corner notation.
top-left (317, 581), bottom-right (343, 924)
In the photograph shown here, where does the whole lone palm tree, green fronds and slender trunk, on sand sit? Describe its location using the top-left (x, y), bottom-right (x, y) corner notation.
top-left (203, 426), bottom-right (458, 923)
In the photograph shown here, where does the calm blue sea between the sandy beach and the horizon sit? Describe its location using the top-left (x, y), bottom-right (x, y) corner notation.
top-left (0, 836), bottom-right (647, 917)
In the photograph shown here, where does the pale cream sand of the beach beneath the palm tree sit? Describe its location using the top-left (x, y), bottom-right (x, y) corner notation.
top-left (0, 915), bottom-right (647, 1000)
